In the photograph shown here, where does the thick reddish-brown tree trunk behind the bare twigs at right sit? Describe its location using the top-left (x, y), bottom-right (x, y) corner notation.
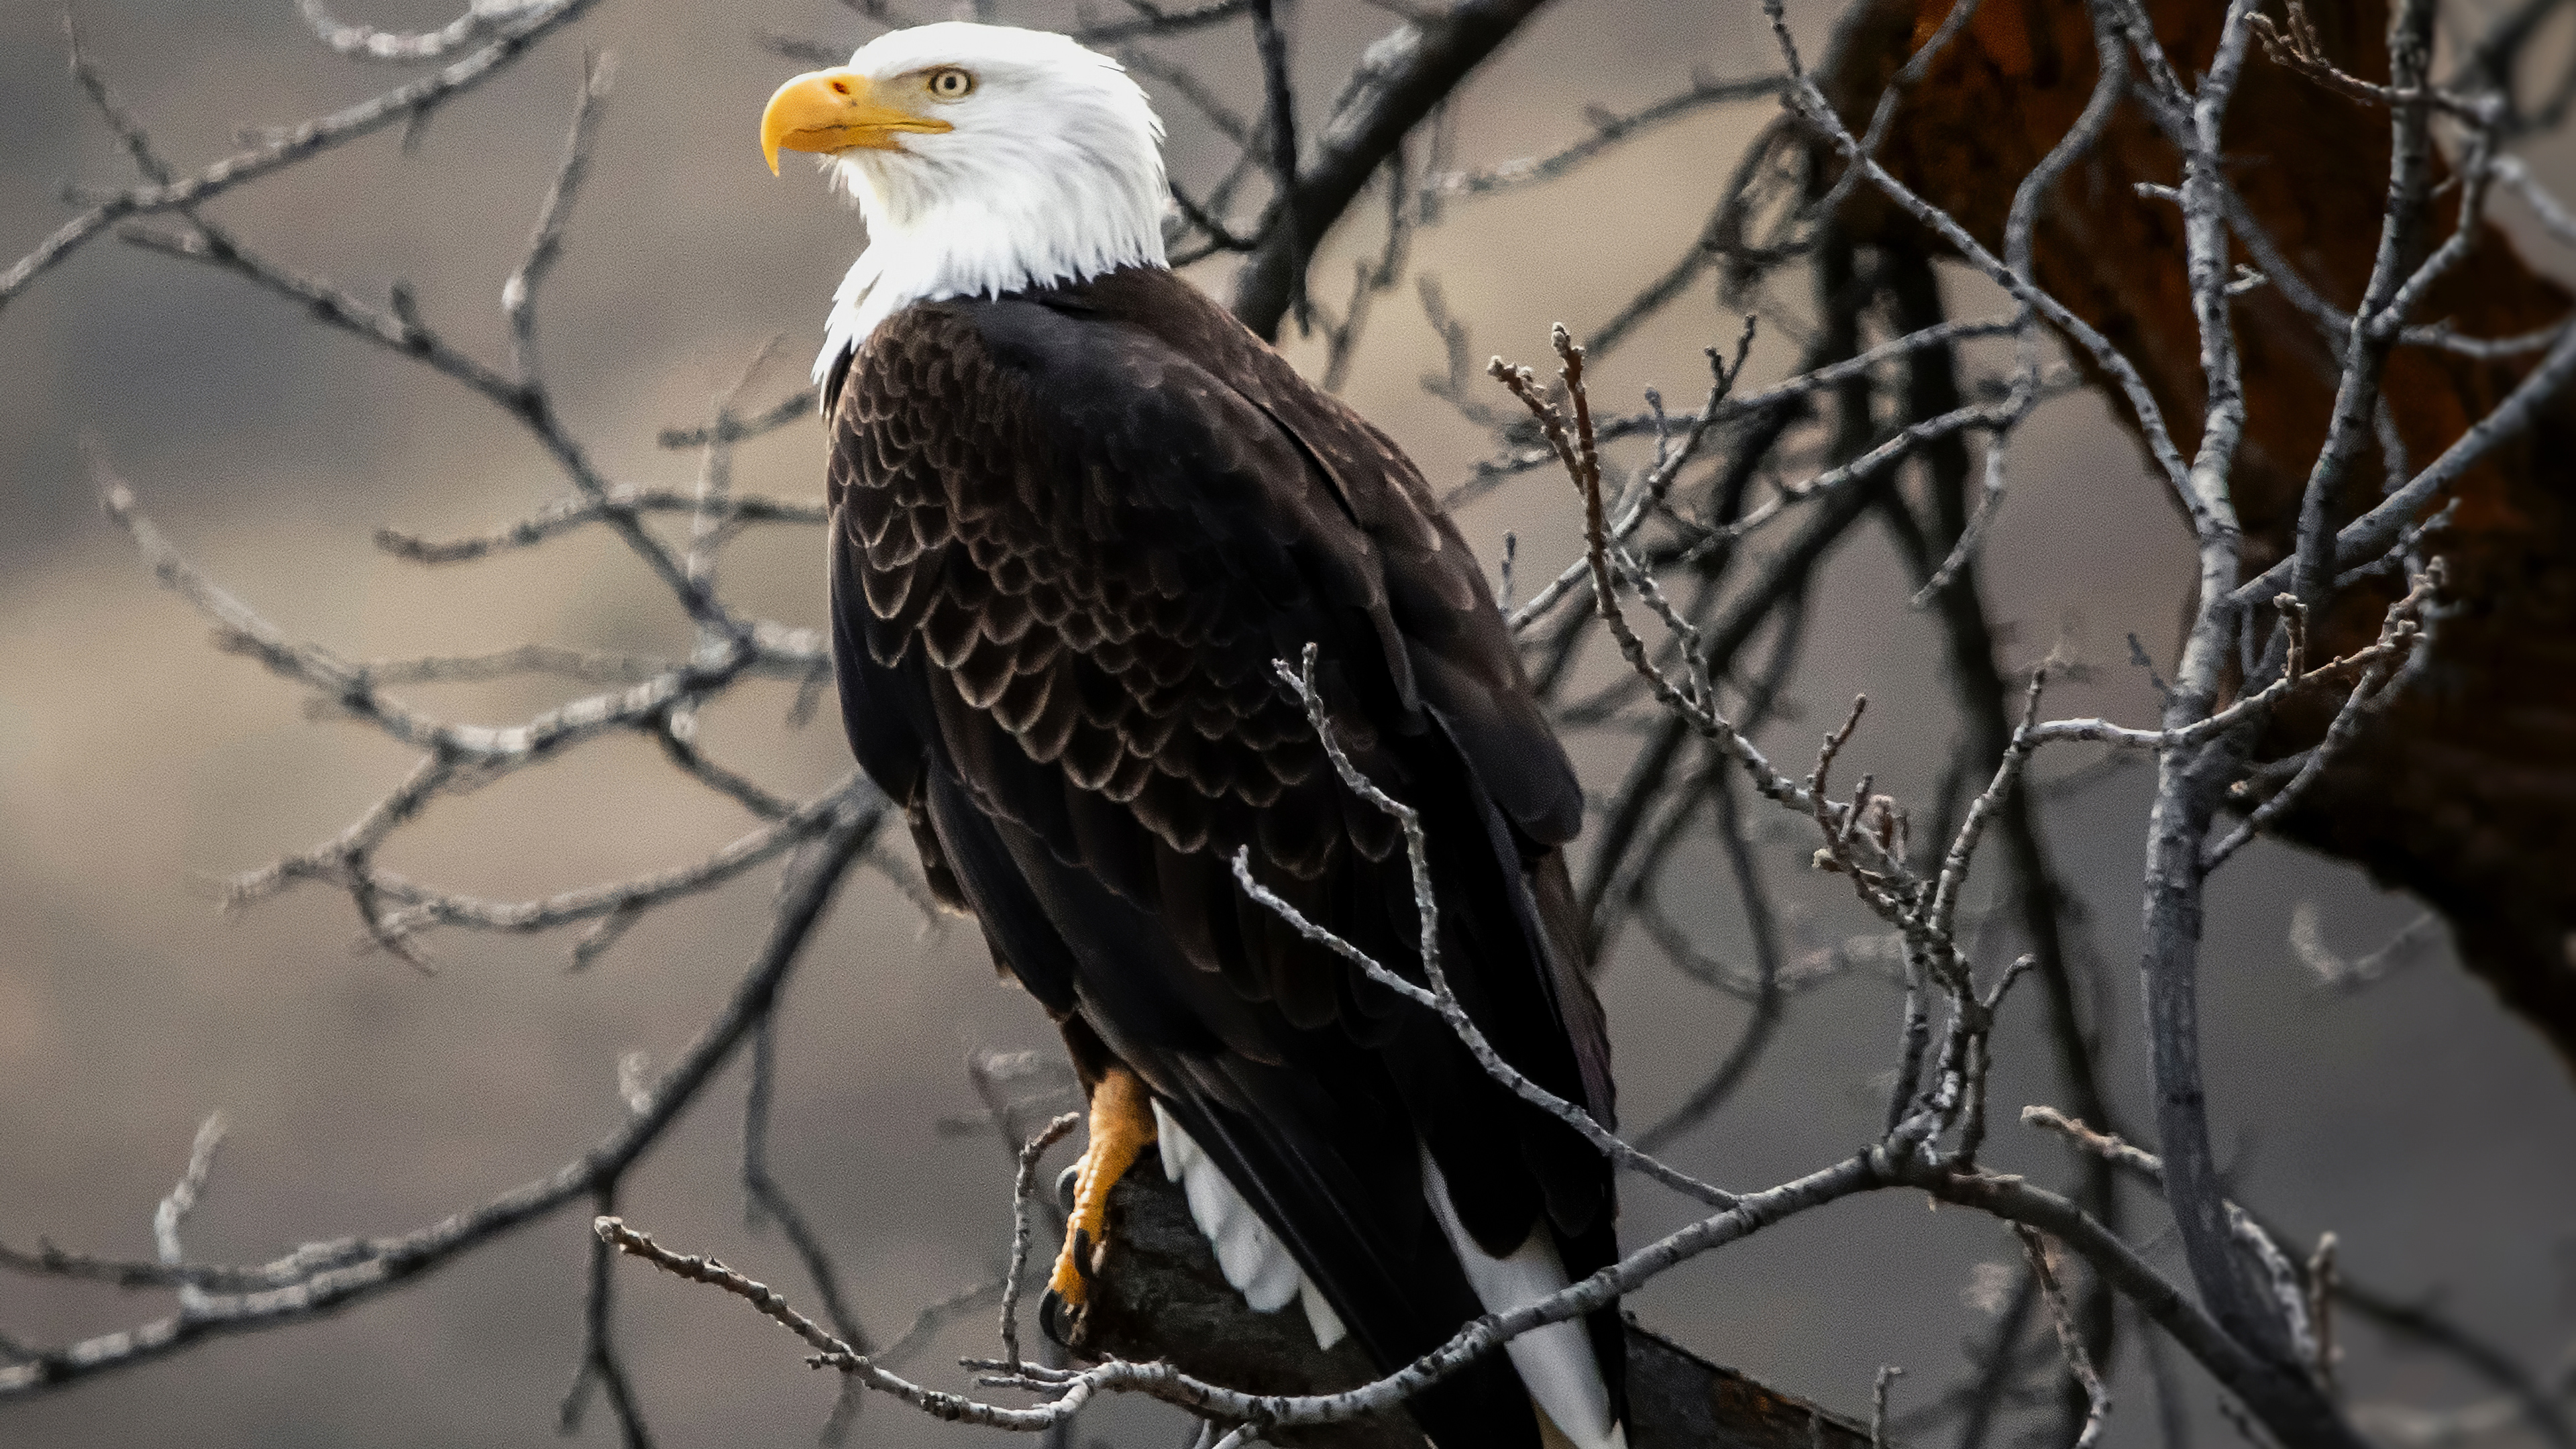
top-left (1827, 0), bottom-right (2576, 1070)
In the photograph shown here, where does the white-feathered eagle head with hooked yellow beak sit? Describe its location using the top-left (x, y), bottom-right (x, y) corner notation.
top-left (760, 21), bottom-right (1167, 382)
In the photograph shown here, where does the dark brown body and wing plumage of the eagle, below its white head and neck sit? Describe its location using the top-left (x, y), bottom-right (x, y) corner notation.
top-left (829, 268), bottom-right (1623, 1444)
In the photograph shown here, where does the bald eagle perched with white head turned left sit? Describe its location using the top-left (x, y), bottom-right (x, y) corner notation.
top-left (760, 23), bottom-right (1625, 1449)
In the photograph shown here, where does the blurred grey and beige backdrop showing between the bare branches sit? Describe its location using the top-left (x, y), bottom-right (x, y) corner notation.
top-left (0, 0), bottom-right (2576, 1446)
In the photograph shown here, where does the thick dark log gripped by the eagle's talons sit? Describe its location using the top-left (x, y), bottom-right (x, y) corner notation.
top-left (1071, 1152), bottom-right (1870, 1449)
